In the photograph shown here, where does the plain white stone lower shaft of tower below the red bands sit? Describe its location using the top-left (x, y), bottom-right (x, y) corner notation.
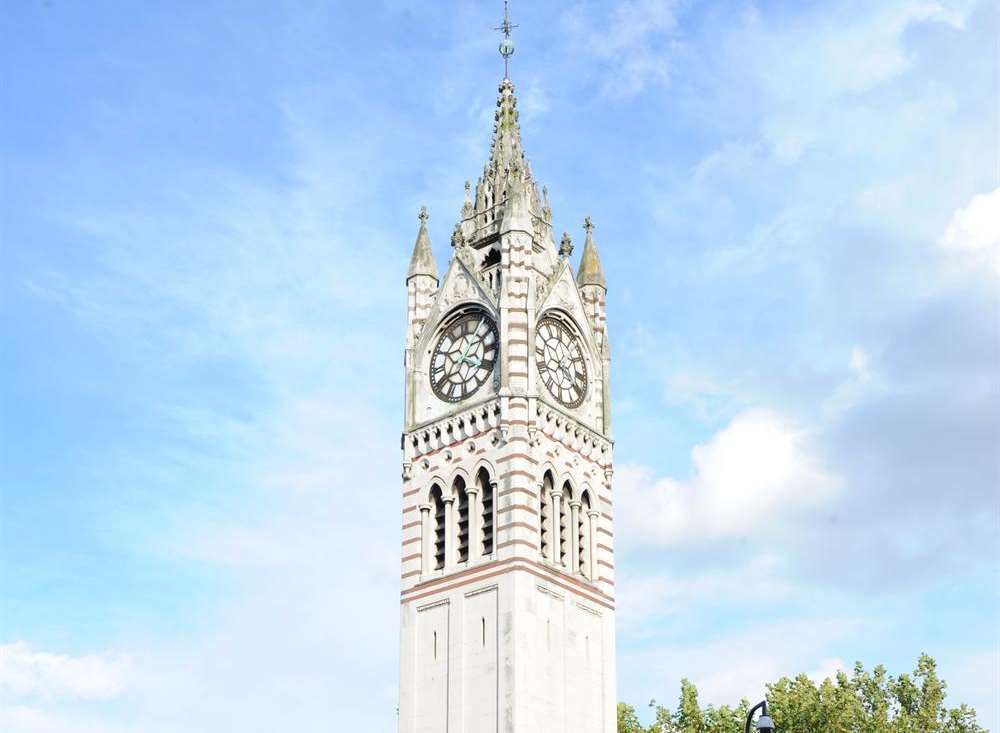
top-left (400, 565), bottom-right (616, 733)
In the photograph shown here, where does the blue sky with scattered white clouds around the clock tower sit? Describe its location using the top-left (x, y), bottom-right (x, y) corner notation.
top-left (0, 0), bottom-right (1000, 733)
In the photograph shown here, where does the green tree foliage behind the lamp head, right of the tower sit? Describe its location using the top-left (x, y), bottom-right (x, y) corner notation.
top-left (618, 654), bottom-right (987, 733)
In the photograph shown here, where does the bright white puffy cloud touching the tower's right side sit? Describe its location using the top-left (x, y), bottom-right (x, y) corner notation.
top-left (617, 410), bottom-right (839, 545)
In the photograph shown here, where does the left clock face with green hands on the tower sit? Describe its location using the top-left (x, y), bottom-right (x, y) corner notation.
top-left (430, 313), bottom-right (500, 402)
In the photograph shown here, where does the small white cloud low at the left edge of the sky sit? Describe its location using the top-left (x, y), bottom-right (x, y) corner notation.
top-left (0, 641), bottom-right (130, 700)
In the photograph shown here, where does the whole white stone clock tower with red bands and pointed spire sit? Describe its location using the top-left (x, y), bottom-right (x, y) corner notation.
top-left (399, 78), bottom-right (616, 733)
